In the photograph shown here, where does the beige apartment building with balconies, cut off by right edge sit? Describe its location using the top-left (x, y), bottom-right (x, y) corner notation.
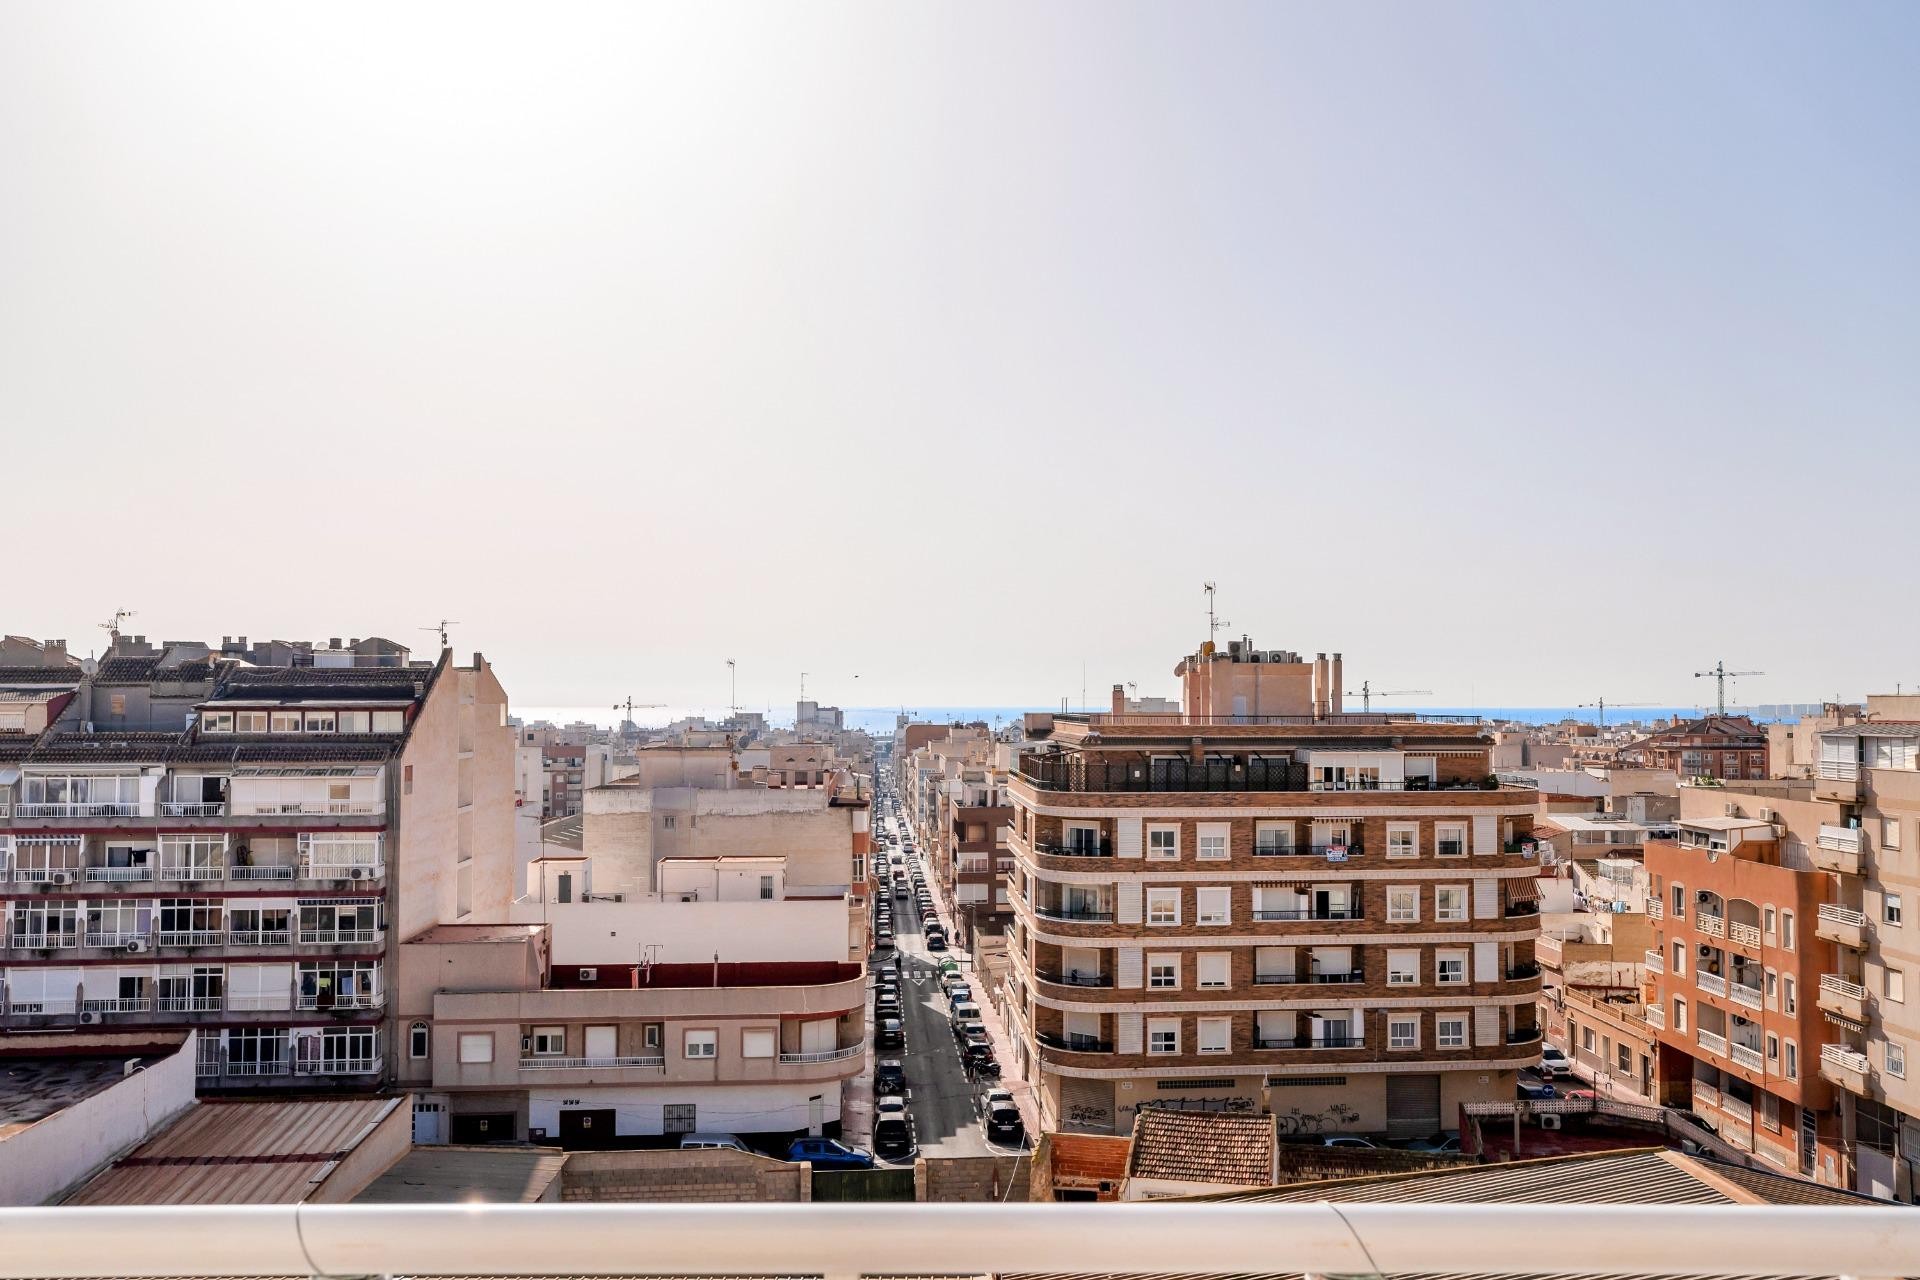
top-left (1811, 710), bottom-right (1920, 1201)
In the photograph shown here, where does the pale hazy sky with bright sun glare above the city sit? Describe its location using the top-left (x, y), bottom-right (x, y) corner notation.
top-left (0, 0), bottom-right (1920, 706)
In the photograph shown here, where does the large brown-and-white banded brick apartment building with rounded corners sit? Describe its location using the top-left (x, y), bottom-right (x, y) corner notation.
top-left (1008, 641), bottom-right (1540, 1138)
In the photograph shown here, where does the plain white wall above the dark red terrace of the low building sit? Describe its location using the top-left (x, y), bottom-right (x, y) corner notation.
top-left (511, 898), bottom-right (847, 965)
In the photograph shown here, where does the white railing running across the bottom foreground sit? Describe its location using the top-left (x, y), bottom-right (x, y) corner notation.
top-left (0, 1201), bottom-right (1920, 1280)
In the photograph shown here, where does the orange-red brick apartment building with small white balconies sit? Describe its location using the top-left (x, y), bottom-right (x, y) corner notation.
top-left (1645, 781), bottom-right (1864, 1186)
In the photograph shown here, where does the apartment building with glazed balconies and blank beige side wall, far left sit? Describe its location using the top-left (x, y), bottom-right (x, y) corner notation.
top-left (0, 645), bottom-right (513, 1088)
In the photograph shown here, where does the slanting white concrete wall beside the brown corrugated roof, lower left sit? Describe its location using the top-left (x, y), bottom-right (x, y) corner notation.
top-left (0, 1036), bottom-right (194, 1205)
